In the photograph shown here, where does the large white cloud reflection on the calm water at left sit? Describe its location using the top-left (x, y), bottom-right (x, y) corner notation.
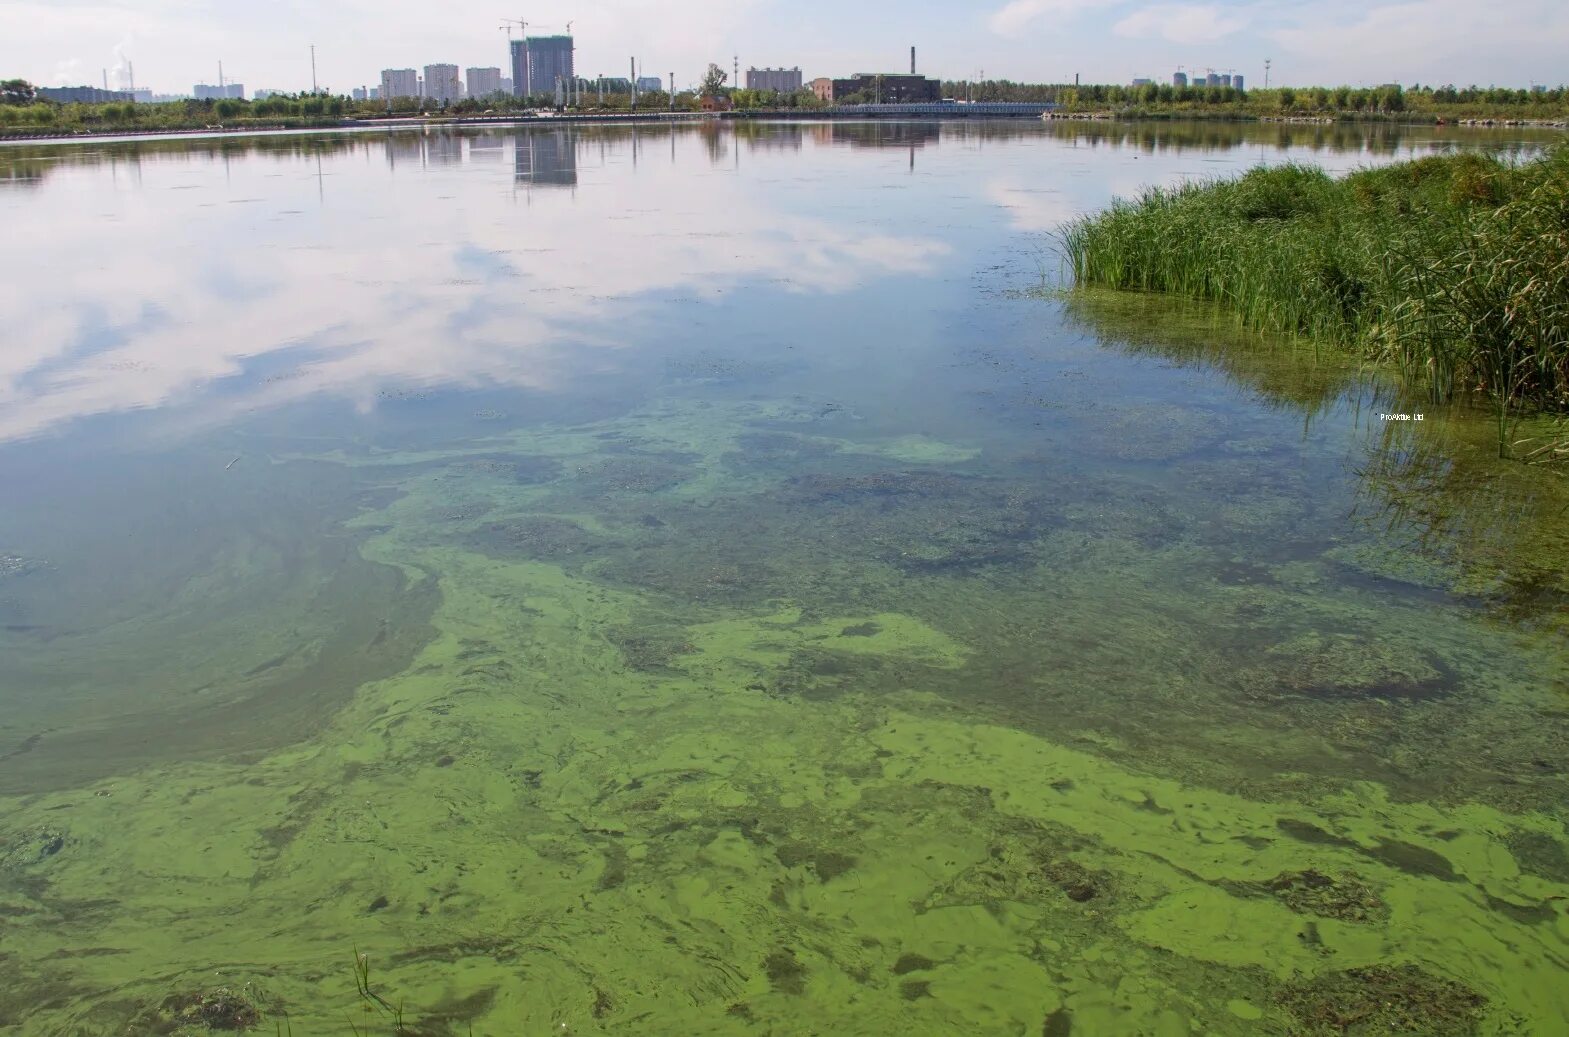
top-left (0, 127), bottom-right (948, 441)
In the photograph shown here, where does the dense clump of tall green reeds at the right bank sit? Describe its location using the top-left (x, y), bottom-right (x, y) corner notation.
top-left (1064, 147), bottom-right (1569, 436)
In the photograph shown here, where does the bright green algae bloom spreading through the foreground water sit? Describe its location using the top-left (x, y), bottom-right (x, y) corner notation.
top-left (0, 382), bottom-right (1569, 1035)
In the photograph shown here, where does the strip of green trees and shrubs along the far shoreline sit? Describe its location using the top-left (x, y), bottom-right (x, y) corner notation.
top-left (0, 80), bottom-right (1569, 140)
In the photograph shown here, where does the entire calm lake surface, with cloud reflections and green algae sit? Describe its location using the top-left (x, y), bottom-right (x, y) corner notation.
top-left (0, 122), bottom-right (1569, 1037)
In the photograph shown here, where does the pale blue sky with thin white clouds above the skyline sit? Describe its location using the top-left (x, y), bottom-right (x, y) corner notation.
top-left (0, 0), bottom-right (1569, 94)
